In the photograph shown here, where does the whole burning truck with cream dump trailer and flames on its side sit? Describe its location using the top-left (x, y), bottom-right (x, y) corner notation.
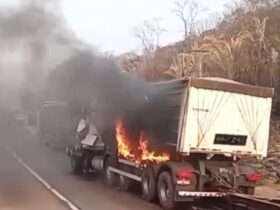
top-left (67, 78), bottom-right (273, 210)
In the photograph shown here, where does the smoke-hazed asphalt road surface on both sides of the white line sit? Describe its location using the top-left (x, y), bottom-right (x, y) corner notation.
top-left (0, 118), bottom-right (160, 210)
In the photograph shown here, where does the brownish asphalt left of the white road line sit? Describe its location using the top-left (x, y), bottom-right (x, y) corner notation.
top-left (0, 143), bottom-right (66, 210)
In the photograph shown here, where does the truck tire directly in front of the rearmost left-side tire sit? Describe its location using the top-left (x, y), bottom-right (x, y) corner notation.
top-left (141, 168), bottom-right (156, 201)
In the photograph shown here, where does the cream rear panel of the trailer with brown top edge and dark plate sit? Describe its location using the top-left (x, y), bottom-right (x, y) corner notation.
top-left (177, 78), bottom-right (273, 157)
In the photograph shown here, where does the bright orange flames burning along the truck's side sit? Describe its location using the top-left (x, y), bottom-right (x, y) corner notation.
top-left (116, 121), bottom-right (170, 163)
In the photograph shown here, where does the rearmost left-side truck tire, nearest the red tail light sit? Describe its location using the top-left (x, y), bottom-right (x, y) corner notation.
top-left (157, 171), bottom-right (176, 210)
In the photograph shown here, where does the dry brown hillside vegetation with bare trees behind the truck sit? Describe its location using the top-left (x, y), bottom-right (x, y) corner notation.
top-left (120, 0), bottom-right (280, 101)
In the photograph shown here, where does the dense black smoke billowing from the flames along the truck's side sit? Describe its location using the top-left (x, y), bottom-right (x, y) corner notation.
top-left (48, 51), bottom-right (181, 151)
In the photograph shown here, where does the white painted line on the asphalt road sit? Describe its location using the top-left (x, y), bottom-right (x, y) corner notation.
top-left (8, 150), bottom-right (81, 210)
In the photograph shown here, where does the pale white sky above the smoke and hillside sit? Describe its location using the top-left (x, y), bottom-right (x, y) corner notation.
top-left (0, 0), bottom-right (230, 54)
